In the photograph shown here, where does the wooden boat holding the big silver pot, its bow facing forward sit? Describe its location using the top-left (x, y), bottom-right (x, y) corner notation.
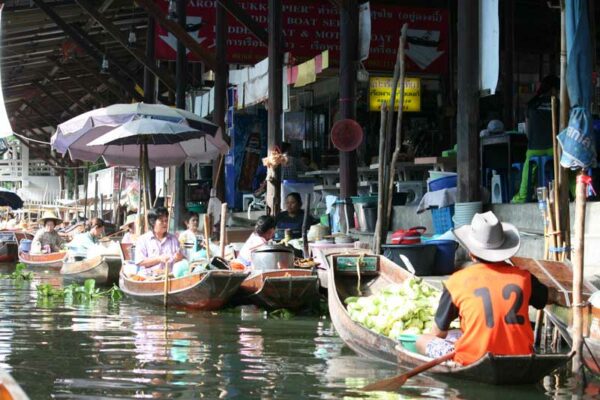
top-left (240, 268), bottom-right (319, 310)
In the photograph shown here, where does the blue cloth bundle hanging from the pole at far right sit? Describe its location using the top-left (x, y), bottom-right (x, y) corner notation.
top-left (558, 0), bottom-right (596, 169)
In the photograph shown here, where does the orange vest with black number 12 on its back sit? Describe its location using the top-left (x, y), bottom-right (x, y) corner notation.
top-left (446, 263), bottom-right (533, 365)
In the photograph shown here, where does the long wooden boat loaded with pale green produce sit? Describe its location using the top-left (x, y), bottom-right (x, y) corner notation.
top-left (327, 254), bottom-right (570, 384)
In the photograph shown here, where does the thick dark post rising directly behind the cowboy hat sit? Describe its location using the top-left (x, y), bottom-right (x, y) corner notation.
top-left (456, 0), bottom-right (481, 203)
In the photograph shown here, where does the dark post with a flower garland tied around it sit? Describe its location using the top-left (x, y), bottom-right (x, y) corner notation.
top-left (267, 0), bottom-right (283, 215)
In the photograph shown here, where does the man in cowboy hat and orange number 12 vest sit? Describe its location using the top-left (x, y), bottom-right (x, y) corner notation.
top-left (417, 211), bottom-right (548, 365)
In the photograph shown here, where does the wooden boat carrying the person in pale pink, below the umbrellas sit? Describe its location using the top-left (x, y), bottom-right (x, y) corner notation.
top-left (119, 270), bottom-right (249, 311)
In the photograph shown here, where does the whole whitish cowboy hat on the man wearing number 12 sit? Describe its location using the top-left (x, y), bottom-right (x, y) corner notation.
top-left (453, 211), bottom-right (521, 262)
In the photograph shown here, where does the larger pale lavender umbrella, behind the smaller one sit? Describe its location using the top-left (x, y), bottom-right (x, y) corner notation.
top-left (51, 103), bottom-right (218, 162)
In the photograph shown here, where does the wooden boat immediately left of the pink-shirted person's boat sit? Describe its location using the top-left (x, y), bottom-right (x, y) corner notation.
top-left (60, 256), bottom-right (122, 285)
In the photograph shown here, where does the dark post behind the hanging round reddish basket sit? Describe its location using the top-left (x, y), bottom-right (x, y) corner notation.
top-left (339, 0), bottom-right (358, 211)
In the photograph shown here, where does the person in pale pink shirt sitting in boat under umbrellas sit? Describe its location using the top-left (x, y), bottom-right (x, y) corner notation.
top-left (135, 207), bottom-right (184, 272)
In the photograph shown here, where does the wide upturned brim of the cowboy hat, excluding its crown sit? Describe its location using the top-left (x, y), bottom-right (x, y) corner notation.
top-left (452, 222), bottom-right (521, 262)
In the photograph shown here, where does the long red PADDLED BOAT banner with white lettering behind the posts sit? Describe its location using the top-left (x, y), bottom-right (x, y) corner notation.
top-left (156, 0), bottom-right (449, 73)
